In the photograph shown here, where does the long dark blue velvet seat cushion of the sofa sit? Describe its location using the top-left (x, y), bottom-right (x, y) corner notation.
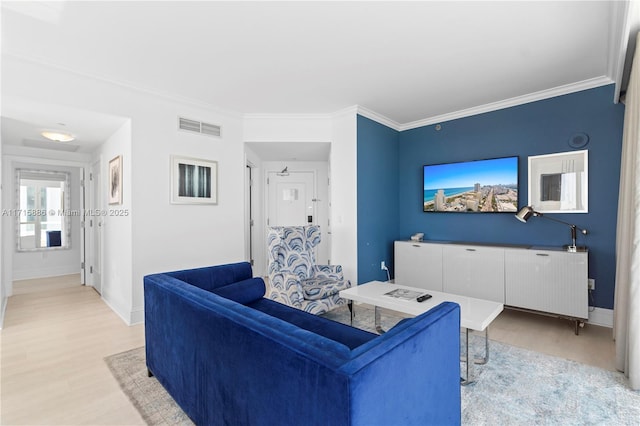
top-left (247, 298), bottom-right (378, 349)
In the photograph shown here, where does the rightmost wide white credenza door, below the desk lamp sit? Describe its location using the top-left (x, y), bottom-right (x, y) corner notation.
top-left (505, 249), bottom-right (589, 319)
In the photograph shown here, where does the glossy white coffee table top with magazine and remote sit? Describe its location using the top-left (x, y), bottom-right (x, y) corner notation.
top-left (340, 281), bottom-right (504, 331)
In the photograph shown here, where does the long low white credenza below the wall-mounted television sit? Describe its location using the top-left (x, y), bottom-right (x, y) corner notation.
top-left (394, 241), bottom-right (589, 322)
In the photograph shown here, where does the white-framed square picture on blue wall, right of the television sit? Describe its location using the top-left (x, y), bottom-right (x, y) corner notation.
top-left (528, 150), bottom-right (589, 213)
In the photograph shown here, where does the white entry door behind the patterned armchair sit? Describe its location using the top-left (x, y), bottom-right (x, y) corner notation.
top-left (267, 172), bottom-right (316, 226)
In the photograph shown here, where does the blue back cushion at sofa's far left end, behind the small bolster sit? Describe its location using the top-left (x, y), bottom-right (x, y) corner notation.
top-left (167, 262), bottom-right (253, 291)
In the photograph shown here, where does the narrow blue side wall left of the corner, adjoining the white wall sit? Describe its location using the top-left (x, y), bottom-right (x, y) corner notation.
top-left (358, 116), bottom-right (399, 284)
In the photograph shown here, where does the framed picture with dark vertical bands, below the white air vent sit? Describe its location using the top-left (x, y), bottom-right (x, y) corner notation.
top-left (171, 156), bottom-right (218, 204)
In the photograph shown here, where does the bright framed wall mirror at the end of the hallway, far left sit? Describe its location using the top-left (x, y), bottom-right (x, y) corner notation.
top-left (15, 169), bottom-right (72, 251)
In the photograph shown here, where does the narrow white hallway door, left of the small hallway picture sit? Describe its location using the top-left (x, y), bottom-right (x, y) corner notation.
top-left (85, 161), bottom-right (102, 294)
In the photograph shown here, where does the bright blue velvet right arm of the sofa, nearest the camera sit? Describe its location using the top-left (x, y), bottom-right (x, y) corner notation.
top-left (341, 302), bottom-right (461, 426)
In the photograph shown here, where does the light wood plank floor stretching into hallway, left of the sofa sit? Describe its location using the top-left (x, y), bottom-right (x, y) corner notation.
top-left (0, 277), bottom-right (144, 425)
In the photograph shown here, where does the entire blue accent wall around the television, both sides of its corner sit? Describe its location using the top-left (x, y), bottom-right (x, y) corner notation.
top-left (358, 85), bottom-right (624, 309)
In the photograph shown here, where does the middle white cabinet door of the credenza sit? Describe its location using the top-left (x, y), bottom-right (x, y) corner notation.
top-left (442, 245), bottom-right (504, 303)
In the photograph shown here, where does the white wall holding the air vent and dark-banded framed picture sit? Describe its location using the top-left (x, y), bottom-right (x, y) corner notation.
top-left (2, 57), bottom-right (245, 323)
